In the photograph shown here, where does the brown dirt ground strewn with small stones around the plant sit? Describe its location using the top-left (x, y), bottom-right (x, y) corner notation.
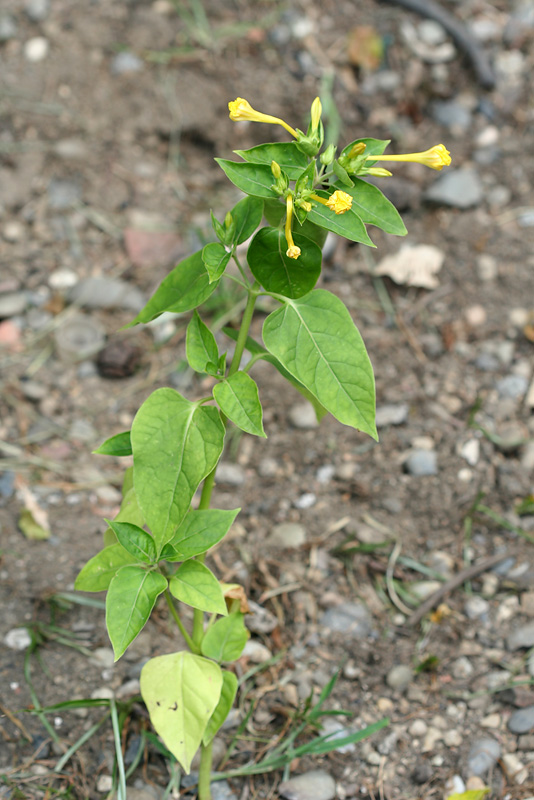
top-left (0, 0), bottom-right (534, 800)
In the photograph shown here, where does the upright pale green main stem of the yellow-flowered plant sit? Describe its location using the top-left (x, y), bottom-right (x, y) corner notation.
top-left (196, 281), bottom-right (260, 800)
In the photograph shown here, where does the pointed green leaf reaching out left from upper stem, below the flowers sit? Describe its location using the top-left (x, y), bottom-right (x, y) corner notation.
top-left (124, 251), bottom-right (218, 328)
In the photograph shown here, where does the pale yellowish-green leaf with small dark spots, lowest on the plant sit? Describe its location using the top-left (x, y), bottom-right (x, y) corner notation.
top-left (141, 651), bottom-right (223, 773)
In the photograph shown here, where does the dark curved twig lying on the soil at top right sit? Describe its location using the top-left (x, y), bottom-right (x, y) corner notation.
top-left (379, 0), bottom-right (496, 89)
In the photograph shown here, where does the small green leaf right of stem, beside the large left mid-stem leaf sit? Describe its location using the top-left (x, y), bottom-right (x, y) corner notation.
top-left (213, 372), bottom-right (266, 438)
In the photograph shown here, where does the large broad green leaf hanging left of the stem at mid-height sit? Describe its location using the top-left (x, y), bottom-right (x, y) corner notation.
top-left (132, 388), bottom-right (228, 547)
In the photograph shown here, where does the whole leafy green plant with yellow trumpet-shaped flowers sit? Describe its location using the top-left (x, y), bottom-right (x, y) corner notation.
top-left (75, 98), bottom-right (450, 800)
